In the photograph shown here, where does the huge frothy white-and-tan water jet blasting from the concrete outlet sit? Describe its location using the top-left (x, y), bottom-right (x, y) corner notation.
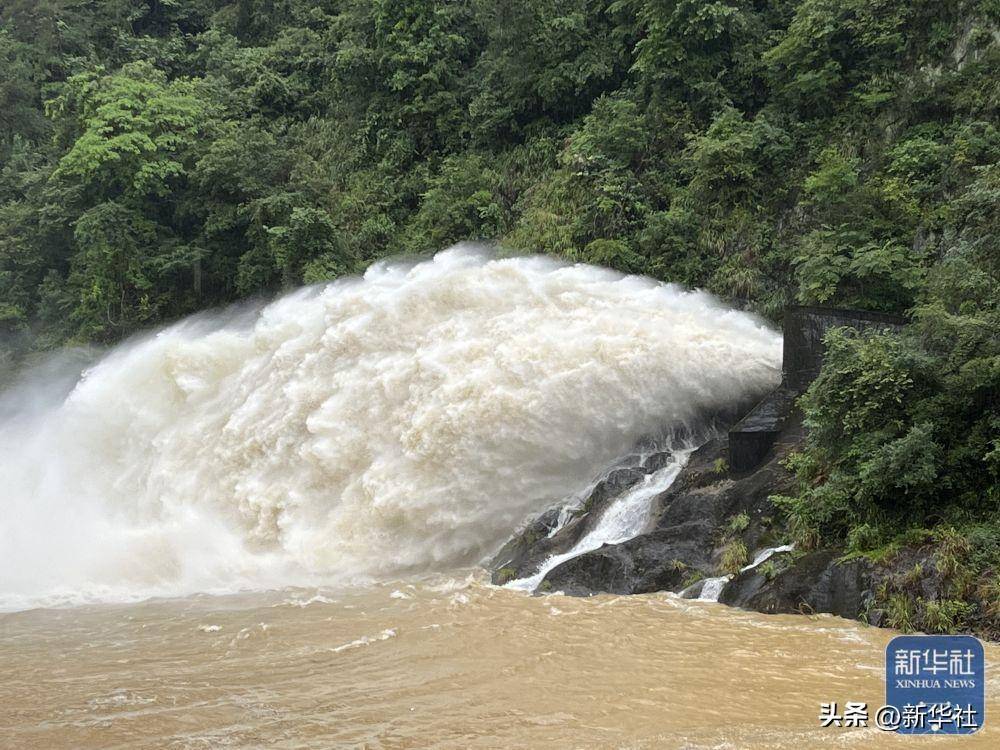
top-left (0, 246), bottom-right (780, 606)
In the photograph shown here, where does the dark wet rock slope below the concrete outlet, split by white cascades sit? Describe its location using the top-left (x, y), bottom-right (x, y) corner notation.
top-left (491, 410), bottom-right (871, 617)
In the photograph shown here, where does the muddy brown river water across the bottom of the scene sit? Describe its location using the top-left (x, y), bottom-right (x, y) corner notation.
top-left (0, 574), bottom-right (1000, 750)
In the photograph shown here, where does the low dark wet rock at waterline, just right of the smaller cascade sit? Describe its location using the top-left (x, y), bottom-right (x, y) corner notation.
top-left (719, 550), bottom-right (872, 619)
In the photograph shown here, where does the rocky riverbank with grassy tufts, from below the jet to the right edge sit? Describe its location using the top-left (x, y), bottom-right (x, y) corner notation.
top-left (491, 400), bottom-right (1000, 640)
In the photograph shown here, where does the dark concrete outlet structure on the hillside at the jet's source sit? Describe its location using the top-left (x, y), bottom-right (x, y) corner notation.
top-left (729, 307), bottom-right (905, 472)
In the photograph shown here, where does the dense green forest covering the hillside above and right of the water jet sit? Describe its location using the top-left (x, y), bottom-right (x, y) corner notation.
top-left (0, 0), bottom-right (1000, 630)
